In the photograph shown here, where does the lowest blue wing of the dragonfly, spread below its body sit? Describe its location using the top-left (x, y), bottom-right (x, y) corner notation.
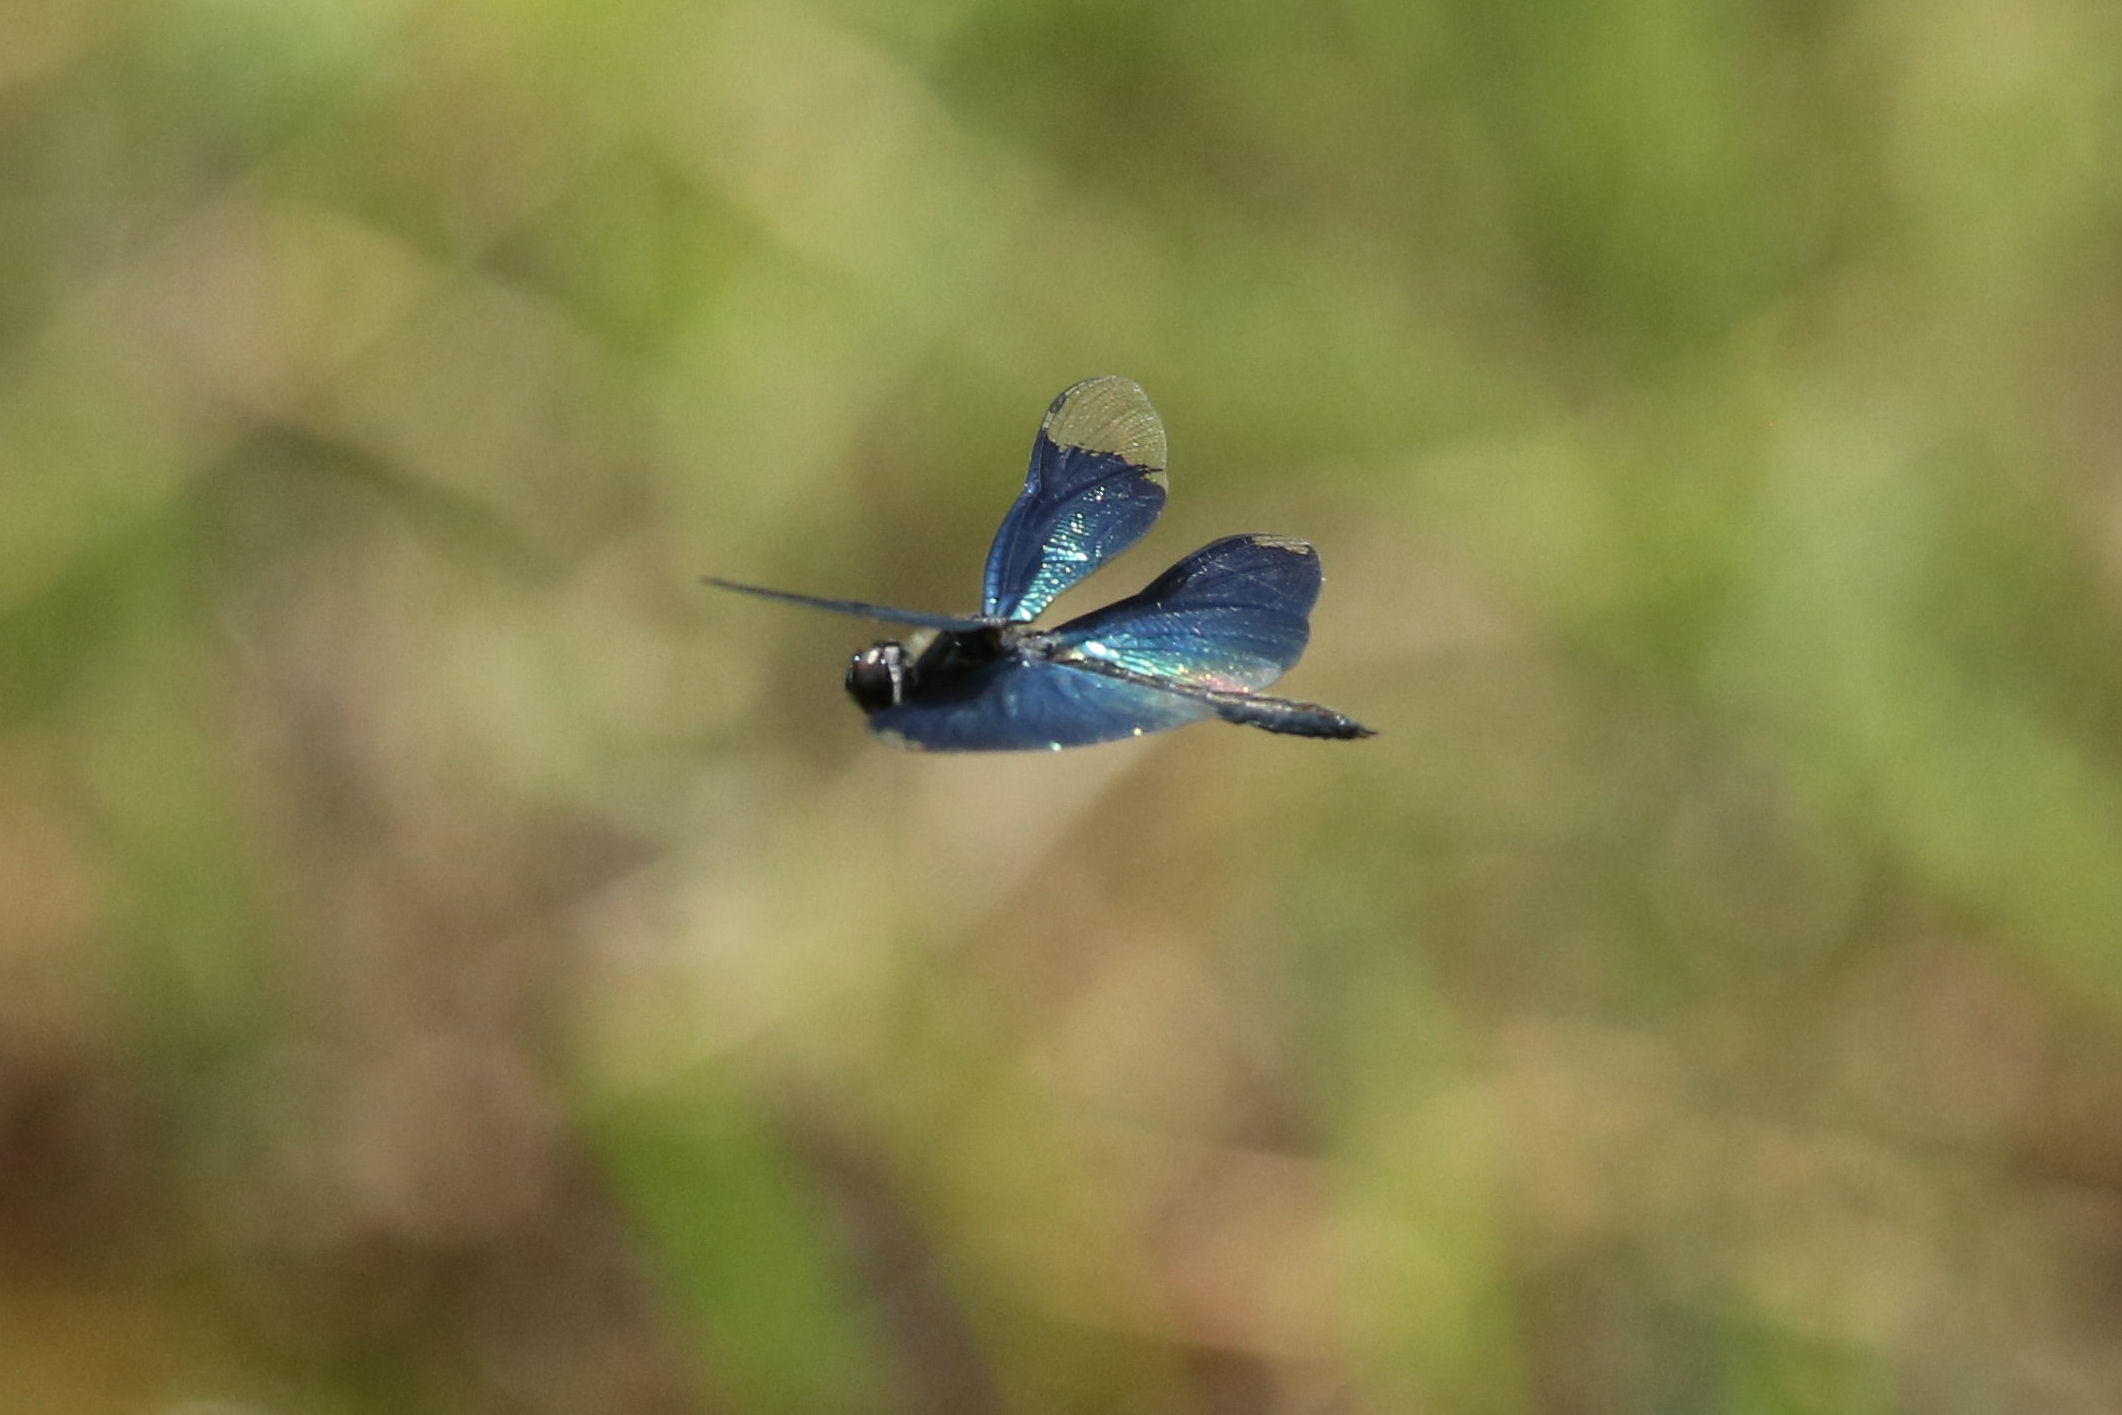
top-left (870, 658), bottom-right (1216, 751)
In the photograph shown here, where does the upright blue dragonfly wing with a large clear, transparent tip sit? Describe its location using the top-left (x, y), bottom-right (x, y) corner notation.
top-left (980, 378), bottom-right (1165, 624)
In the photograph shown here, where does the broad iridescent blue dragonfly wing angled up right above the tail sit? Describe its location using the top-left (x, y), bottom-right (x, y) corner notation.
top-left (1046, 535), bottom-right (1320, 689)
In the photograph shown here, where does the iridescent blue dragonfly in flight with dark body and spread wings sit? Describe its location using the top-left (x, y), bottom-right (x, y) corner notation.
top-left (707, 375), bottom-right (1375, 751)
